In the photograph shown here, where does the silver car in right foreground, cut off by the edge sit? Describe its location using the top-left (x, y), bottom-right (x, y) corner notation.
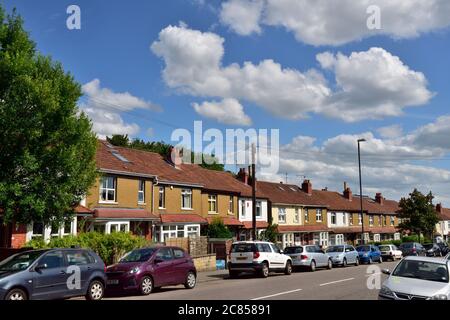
top-left (378, 257), bottom-right (450, 300)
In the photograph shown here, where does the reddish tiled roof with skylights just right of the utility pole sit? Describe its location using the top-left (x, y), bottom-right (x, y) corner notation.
top-left (256, 181), bottom-right (327, 207)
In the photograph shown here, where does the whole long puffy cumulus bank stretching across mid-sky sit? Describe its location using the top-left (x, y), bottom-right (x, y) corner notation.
top-left (151, 26), bottom-right (432, 122)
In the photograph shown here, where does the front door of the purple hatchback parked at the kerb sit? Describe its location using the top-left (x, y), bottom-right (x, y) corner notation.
top-left (153, 248), bottom-right (176, 287)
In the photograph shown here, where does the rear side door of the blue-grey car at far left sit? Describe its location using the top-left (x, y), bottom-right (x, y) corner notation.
top-left (64, 250), bottom-right (95, 296)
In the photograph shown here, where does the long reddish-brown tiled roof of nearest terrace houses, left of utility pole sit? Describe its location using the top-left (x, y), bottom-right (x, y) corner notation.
top-left (96, 140), bottom-right (262, 197)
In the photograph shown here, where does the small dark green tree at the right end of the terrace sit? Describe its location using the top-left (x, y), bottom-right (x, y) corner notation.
top-left (399, 189), bottom-right (439, 238)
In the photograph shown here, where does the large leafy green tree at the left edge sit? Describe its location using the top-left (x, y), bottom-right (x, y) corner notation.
top-left (0, 7), bottom-right (97, 225)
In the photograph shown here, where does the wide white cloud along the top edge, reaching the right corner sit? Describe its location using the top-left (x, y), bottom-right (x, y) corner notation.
top-left (222, 0), bottom-right (450, 46)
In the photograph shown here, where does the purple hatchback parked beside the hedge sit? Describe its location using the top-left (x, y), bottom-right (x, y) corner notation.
top-left (106, 246), bottom-right (197, 295)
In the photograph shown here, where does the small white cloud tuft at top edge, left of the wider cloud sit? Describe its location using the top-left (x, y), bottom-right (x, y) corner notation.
top-left (220, 0), bottom-right (264, 35)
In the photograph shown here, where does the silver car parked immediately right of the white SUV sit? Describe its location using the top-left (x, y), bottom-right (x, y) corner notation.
top-left (284, 245), bottom-right (333, 271)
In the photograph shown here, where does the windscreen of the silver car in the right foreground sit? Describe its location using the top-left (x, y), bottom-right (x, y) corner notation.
top-left (392, 260), bottom-right (448, 283)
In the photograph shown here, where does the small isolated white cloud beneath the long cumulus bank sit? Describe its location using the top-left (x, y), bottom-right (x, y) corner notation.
top-left (192, 98), bottom-right (252, 126)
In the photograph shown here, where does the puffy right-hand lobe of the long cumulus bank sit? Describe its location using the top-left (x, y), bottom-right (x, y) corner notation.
top-left (317, 48), bottom-right (433, 122)
